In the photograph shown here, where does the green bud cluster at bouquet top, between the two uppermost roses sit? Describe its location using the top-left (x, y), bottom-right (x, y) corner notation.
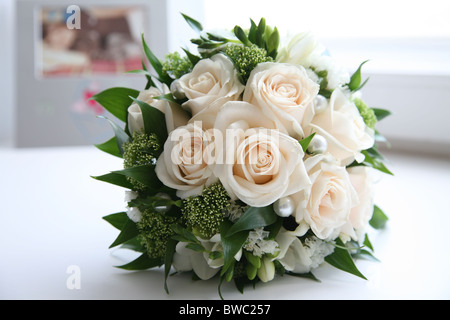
top-left (224, 44), bottom-right (273, 84)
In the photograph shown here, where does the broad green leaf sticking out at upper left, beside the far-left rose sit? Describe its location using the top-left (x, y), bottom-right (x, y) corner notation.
top-left (91, 87), bottom-right (139, 122)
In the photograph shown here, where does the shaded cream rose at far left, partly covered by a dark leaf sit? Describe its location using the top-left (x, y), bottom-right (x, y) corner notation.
top-left (128, 85), bottom-right (189, 133)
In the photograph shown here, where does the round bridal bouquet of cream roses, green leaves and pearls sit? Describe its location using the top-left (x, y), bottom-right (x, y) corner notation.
top-left (92, 15), bottom-right (391, 292)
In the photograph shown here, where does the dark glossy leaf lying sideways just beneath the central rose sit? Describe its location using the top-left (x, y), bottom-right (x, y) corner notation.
top-left (227, 205), bottom-right (277, 236)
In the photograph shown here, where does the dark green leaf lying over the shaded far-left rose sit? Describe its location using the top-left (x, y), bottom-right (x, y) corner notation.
top-left (130, 99), bottom-right (168, 145)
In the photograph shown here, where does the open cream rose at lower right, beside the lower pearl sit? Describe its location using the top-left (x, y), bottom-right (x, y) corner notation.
top-left (293, 155), bottom-right (358, 239)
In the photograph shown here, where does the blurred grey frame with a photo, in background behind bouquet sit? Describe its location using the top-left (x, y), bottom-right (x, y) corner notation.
top-left (14, 0), bottom-right (168, 147)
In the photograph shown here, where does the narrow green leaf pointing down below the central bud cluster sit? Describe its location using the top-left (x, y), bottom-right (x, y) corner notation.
top-left (219, 219), bottom-right (248, 275)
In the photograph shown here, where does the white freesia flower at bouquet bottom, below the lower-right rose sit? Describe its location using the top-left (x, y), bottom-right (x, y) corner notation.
top-left (275, 228), bottom-right (334, 273)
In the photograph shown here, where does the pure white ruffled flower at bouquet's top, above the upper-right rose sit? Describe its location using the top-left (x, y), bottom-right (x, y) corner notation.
top-left (276, 32), bottom-right (324, 67)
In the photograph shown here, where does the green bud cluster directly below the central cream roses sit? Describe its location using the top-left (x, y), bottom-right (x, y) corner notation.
top-left (181, 183), bottom-right (230, 239)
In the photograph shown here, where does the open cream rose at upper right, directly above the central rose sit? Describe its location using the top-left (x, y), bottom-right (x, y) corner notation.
top-left (243, 62), bottom-right (319, 139)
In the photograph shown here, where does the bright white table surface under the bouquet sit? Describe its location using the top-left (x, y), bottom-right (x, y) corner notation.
top-left (0, 147), bottom-right (450, 300)
